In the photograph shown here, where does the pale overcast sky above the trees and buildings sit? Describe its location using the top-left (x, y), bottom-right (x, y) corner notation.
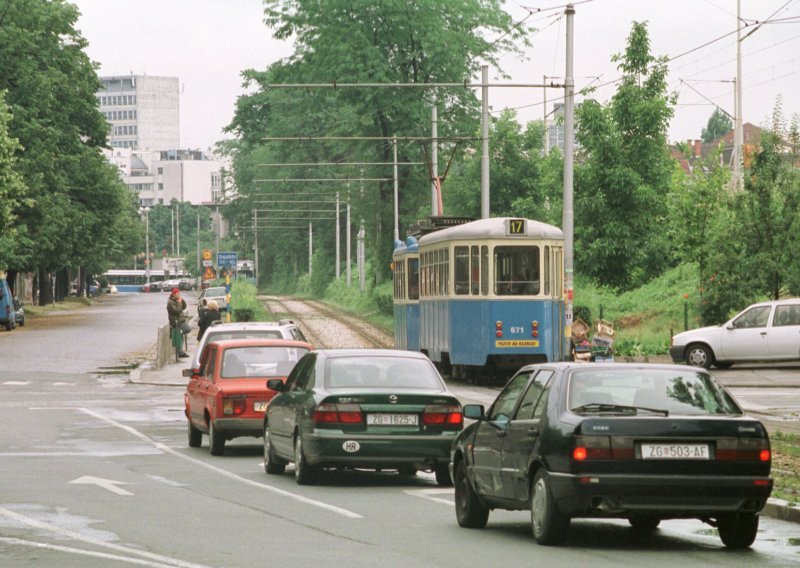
top-left (72, 0), bottom-right (800, 149)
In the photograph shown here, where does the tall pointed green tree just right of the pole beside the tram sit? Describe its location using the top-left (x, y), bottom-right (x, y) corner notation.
top-left (575, 22), bottom-right (674, 289)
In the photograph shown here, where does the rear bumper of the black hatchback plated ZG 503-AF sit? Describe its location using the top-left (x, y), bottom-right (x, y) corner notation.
top-left (550, 473), bottom-right (772, 518)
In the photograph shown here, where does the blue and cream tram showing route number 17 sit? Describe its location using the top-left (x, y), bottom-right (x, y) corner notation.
top-left (395, 218), bottom-right (568, 382)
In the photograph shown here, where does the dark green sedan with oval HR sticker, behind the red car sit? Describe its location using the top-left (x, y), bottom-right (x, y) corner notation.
top-left (264, 349), bottom-right (463, 486)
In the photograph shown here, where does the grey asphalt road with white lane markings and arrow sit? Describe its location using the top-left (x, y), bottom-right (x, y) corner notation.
top-left (0, 294), bottom-right (800, 568)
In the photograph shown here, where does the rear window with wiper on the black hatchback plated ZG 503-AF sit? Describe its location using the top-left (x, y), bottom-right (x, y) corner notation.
top-left (568, 369), bottom-right (742, 416)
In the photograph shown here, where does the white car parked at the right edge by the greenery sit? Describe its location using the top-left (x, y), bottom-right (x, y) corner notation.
top-left (669, 298), bottom-right (800, 369)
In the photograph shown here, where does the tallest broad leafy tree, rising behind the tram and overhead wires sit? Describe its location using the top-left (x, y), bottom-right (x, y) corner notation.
top-left (230, 0), bottom-right (527, 290)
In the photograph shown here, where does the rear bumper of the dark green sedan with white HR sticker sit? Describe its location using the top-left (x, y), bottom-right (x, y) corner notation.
top-left (303, 430), bottom-right (458, 469)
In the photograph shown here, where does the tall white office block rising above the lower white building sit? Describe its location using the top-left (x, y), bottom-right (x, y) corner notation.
top-left (97, 75), bottom-right (180, 151)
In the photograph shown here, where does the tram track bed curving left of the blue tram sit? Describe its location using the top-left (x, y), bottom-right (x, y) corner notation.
top-left (259, 296), bottom-right (394, 349)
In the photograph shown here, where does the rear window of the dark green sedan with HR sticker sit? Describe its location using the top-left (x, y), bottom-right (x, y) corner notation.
top-left (325, 357), bottom-right (443, 390)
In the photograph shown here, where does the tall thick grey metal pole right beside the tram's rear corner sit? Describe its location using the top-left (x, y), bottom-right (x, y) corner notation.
top-left (563, 4), bottom-right (575, 356)
